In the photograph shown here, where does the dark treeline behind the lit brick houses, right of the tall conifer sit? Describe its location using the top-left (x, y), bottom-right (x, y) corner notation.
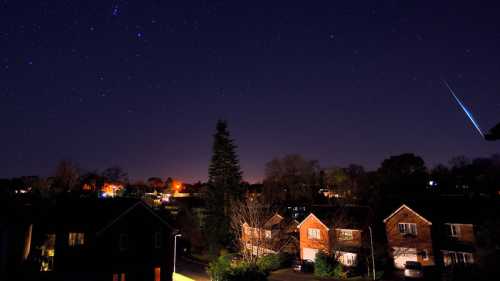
top-left (263, 153), bottom-right (500, 205)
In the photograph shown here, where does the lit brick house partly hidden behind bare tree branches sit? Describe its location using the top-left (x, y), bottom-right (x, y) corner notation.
top-left (242, 213), bottom-right (299, 256)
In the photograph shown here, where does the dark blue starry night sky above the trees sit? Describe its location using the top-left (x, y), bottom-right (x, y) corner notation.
top-left (0, 0), bottom-right (500, 182)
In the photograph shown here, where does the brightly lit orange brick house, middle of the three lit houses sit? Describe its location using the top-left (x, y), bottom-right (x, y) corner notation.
top-left (297, 205), bottom-right (372, 266)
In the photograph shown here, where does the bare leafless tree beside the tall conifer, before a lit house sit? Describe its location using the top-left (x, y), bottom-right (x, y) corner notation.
top-left (230, 199), bottom-right (271, 263)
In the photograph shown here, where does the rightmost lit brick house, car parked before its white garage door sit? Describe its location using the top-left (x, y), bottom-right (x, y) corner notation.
top-left (384, 202), bottom-right (475, 269)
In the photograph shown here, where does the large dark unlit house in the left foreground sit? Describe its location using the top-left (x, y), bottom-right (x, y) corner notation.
top-left (31, 199), bottom-right (175, 281)
